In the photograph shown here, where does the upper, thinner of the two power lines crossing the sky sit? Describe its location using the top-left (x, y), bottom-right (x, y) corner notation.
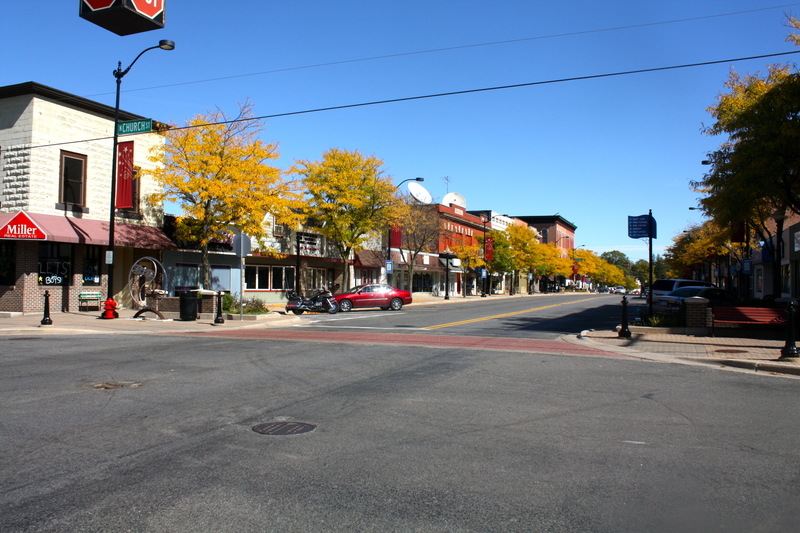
top-left (88, 2), bottom-right (800, 97)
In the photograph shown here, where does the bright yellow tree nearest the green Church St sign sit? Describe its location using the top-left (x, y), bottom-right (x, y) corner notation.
top-left (147, 102), bottom-right (300, 288)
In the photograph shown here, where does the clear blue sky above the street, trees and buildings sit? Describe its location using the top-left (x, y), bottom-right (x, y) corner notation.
top-left (6, 0), bottom-right (800, 260)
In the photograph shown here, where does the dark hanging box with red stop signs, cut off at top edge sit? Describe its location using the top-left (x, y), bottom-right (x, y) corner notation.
top-left (79, 0), bottom-right (166, 35)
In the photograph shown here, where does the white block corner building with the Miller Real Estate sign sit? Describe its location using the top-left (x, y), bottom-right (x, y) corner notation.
top-left (0, 82), bottom-right (174, 313)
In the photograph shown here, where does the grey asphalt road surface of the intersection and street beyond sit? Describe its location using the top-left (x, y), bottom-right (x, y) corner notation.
top-left (0, 301), bottom-right (800, 532)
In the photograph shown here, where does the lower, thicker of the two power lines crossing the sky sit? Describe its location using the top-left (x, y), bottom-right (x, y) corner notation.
top-left (21, 50), bottom-right (800, 149)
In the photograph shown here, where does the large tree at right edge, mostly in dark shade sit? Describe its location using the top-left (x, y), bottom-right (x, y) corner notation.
top-left (691, 18), bottom-right (800, 229)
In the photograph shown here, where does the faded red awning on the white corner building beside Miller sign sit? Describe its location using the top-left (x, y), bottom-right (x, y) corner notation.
top-left (0, 212), bottom-right (176, 250)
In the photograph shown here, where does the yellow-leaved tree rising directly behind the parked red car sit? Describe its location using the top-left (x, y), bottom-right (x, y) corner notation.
top-left (290, 148), bottom-right (406, 287)
